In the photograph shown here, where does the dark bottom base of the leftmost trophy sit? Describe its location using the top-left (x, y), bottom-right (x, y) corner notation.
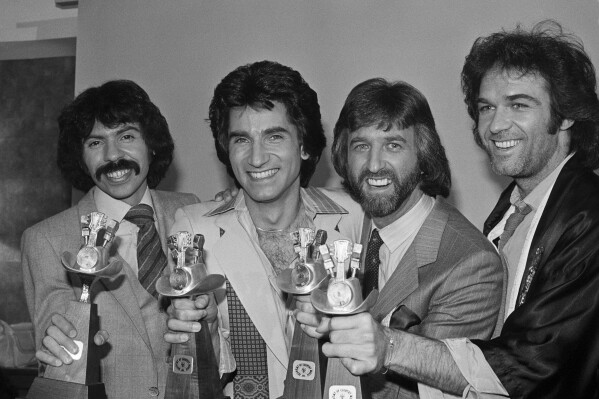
top-left (26, 377), bottom-right (107, 399)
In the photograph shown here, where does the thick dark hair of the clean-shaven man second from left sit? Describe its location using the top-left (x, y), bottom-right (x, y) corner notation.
top-left (209, 61), bottom-right (326, 187)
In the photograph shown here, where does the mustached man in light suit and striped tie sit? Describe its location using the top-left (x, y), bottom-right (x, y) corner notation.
top-left (22, 80), bottom-right (199, 398)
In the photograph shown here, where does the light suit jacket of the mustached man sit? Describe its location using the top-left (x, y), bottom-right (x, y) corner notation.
top-left (21, 190), bottom-right (198, 399)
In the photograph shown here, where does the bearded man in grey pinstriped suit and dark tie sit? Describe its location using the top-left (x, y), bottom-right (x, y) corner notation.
top-left (297, 79), bottom-right (504, 398)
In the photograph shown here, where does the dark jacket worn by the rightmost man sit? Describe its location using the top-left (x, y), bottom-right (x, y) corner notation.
top-left (473, 155), bottom-right (599, 399)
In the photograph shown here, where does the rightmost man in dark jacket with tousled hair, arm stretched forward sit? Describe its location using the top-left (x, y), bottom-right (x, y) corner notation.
top-left (312, 21), bottom-right (599, 399)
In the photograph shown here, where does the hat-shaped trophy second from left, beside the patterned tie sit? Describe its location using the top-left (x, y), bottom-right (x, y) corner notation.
top-left (156, 231), bottom-right (225, 399)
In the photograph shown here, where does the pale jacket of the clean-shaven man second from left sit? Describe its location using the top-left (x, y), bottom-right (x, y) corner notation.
top-left (173, 188), bottom-right (363, 398)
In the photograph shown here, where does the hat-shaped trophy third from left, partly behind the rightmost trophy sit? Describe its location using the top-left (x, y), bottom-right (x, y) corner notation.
top-left (277, 228), bottom-right (328, 399)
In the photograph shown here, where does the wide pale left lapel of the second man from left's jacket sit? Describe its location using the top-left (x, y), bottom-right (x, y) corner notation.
top-left (211, 212), bottom-right (288, 365)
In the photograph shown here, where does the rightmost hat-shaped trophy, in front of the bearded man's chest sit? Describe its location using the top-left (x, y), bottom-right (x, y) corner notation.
top-left (310, 240), bottom-right (378, 399)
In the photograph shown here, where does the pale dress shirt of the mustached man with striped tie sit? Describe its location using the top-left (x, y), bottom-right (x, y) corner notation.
top-left (92, 186), bottom-right (158, 275)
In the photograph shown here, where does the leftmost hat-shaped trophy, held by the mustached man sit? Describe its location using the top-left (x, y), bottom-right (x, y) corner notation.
top-left (27, 212), bottom-right (123, 399)
